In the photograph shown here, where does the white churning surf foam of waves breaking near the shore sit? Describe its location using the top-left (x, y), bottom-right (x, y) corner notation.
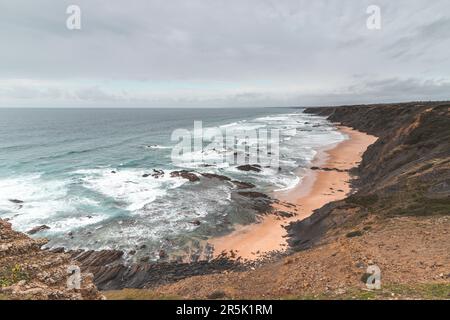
top-left (0, 109), bottom-right (346, 254)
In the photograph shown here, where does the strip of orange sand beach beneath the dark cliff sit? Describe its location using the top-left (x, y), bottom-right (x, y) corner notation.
top-left (208, 126), bottom-right (377, 260)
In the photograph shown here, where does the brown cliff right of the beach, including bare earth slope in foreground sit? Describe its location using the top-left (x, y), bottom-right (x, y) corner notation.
top-left (142, 102), bottom-right (450, 299)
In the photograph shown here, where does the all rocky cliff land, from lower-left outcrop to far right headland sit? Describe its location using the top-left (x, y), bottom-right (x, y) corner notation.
top-left (0, 102), bottom-right (450, 299)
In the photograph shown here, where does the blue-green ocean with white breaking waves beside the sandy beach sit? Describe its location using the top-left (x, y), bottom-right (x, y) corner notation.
top-left (0, 108), bottom-right (346, 259)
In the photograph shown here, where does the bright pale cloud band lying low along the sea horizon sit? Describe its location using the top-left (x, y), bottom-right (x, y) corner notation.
top-left (0, 77), bottom-right (450, 108)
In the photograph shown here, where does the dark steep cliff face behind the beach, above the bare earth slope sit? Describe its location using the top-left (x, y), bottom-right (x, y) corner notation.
top-left (289, 102), bottom-right (450, 250)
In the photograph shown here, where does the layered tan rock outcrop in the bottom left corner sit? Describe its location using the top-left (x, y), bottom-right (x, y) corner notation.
top-left (0, 220), bottom-right (103, 300)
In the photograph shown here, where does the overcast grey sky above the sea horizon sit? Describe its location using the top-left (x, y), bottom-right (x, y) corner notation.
top-left (0, 0), bottom-right (450, 108)
